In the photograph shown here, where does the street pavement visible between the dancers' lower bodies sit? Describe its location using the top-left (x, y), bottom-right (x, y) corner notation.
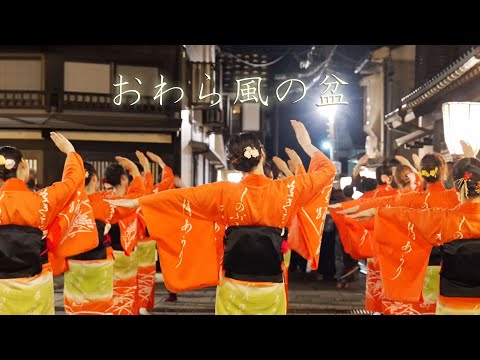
top-left (55, 272), bottom-right (367, 315)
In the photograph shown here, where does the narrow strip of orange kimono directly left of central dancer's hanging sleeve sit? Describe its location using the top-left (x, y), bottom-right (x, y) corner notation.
top-left (137, 166), bottom-right (175, 310)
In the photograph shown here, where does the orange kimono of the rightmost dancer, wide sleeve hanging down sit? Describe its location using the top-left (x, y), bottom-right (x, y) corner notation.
top-left (375, 201), bottom-right (480, 315)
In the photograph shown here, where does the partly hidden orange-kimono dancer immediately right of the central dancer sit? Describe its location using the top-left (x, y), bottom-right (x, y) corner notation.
top-left (330, 159), bottom-right (399, 314)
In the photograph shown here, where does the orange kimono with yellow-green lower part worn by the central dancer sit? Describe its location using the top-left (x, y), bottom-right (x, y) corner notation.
top-left (139, 152), bottom-right (335, 314)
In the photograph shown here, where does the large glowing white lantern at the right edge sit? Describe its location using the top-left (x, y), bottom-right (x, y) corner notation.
top-left (442, 102), bottom-right (480, 155)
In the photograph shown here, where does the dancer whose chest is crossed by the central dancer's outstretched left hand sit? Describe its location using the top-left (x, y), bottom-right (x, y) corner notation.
top-left (89, 156), bottom-right (145, 315)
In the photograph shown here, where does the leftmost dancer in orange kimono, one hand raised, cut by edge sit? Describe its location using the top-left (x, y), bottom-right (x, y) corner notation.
top-left (0, 132), bottom-right (98, 315)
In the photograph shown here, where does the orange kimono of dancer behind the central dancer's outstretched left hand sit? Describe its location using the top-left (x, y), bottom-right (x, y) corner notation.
top-left (89, 176), bottom-right (145, 315)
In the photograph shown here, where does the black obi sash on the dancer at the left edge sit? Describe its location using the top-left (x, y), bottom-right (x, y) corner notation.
top-left (0, 224), bottom-right (48, 279)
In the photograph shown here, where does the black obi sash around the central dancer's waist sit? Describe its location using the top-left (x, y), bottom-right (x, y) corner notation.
top-left (223, 226), bottom-right (287, 283)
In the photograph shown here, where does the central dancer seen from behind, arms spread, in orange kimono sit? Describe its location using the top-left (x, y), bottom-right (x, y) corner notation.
top-left (105, 120), bottom-right (335, 315)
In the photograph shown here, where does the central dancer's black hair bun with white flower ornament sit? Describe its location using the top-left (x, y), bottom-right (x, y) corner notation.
top-left (226, 132), bottom-right (263, 172)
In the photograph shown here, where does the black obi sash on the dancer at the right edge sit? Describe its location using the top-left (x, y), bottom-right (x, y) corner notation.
top-left (440, 239), bottom-right (480, 297)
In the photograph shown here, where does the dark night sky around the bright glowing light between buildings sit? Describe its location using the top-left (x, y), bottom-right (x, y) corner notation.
top-left (220, 45), bottom-right (383, 161)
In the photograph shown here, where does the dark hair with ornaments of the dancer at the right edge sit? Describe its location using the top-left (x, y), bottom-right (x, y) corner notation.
top-left (453, 158), bottom-right (480, 198)
